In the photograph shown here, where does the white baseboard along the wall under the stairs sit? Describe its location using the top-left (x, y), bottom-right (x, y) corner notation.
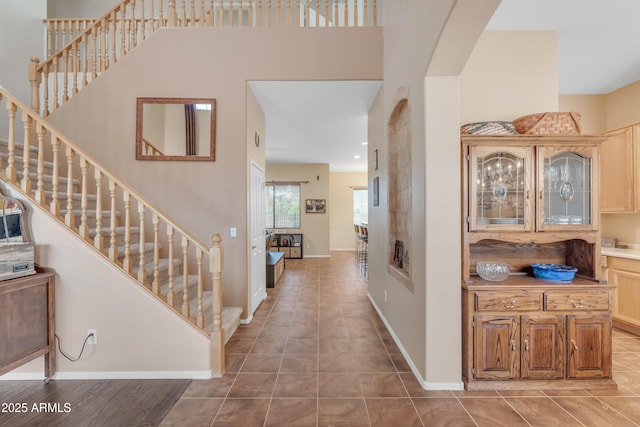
top-left (0, 371), bottom-right (213, 381)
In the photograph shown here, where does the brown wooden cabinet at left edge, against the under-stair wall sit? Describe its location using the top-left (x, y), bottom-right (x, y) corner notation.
top-left (0, 268), bottom-right (56, 378)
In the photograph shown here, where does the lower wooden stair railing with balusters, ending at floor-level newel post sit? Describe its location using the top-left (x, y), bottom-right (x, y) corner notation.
top-left (0, 87), bottom-right (224, 376)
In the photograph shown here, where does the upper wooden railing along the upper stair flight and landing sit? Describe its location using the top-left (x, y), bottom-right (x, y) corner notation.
top-left (28, 0), bottom-right (378, 117)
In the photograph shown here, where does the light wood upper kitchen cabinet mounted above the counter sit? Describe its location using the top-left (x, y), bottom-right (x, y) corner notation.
top-left (600, 125), bottom-right (640, 213)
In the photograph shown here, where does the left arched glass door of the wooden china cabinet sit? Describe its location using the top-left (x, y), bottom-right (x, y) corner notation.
top-left (469, 146), bottom-right (534, 231)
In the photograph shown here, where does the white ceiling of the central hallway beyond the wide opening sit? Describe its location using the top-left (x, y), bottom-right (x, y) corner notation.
top-left (249, 81), bottom-right (382, 172)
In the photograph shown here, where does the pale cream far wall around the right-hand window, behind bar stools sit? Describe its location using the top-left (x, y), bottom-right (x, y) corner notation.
top-left (329, 169), bottom-right (364, 251)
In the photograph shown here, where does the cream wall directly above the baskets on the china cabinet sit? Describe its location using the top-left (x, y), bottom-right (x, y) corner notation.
top-left (460, 31), bottom-right (558, 124)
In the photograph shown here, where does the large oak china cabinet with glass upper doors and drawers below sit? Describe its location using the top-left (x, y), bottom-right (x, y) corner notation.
top-left (462, 135), bottom-right (616, 390)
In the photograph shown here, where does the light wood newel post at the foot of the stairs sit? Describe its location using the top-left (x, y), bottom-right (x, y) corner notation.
top-left (209, 234), bottom-right (224, 377)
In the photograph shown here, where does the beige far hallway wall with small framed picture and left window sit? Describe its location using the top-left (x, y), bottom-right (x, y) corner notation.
top-left (266, 164), bottom-right (333, 257)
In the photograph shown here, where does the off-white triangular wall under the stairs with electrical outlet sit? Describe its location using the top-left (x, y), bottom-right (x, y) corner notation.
top-left (0, 183), bottom-right (211, 379)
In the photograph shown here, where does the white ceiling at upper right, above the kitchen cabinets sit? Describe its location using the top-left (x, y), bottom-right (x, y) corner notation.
top-left (487, 0), bottom-right (640, 95)
